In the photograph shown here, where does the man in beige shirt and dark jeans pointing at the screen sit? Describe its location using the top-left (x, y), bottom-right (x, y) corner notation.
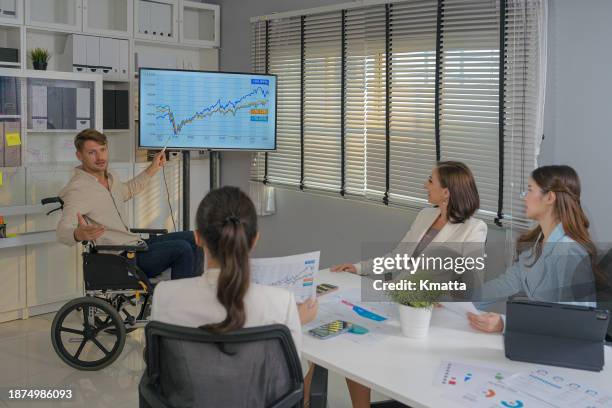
top-left (57, 129), bottom-right (203, 279)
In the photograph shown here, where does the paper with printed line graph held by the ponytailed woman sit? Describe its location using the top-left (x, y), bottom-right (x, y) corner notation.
top-left (251, 251), bottom-right (321, 303)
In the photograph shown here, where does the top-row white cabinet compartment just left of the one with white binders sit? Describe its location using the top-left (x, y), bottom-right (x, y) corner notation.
top-left (83, 0), bottom-right (134, 38)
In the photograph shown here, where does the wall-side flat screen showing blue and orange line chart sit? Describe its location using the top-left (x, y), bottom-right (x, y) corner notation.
top-left (138, 68), bottom-right (276, 151)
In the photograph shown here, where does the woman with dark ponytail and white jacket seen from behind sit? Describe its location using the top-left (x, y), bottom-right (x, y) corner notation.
top-left (151, 187), bottom-right (318, 394)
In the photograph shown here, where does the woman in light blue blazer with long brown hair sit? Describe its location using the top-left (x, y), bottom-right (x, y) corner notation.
top-left (468, 166), bottom-right (597, 332)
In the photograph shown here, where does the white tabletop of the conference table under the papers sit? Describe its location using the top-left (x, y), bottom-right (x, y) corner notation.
top-left (302, 269), bottom-right (612, 408)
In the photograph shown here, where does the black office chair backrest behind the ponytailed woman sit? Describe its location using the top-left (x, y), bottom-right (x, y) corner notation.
top-left (138, 321), bottom-right (304, 408)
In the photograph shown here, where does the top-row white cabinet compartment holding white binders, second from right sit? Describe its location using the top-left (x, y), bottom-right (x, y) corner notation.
top-left (134, 0), bottom-right (179, 42)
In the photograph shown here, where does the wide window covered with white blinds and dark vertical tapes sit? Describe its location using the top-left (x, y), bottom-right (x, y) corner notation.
top-left (251, 0), bottom-right (546, 223)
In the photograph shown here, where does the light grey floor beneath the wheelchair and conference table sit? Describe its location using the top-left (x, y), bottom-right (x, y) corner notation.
top-left (0, 314), bottom-right (379, 408)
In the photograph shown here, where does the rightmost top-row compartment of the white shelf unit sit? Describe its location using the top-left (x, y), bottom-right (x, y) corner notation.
top-left (179, 0), bottom-right (221, 47)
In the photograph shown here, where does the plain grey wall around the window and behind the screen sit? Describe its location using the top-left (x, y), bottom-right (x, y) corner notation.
top-left (213, 0), bottom-right (612, 267)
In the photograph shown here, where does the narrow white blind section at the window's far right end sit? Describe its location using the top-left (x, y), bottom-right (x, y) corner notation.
top-left (503, 0), bottom-right (546, 226)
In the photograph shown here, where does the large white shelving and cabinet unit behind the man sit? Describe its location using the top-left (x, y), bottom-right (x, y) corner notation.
top-left (0, 0), bottom-right (220, 322)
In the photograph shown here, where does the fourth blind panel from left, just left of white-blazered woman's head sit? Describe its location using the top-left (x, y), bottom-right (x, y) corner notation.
top-left (390, 0), bottom-right (438, 202)
